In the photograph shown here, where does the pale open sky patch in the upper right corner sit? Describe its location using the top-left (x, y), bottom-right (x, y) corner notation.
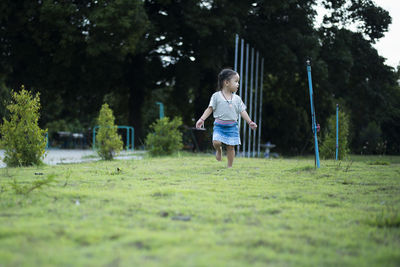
top-left (374, 0), bottom-right (400, 68)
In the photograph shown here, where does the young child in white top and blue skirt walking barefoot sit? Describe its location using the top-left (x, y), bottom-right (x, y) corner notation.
top-left (196, 69), bottom-right (257, 168)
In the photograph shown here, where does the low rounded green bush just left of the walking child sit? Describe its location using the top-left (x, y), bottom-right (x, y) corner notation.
top-left (146, 117), bottom-right (183, 156)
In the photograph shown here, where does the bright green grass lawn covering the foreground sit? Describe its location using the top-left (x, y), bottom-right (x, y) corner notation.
top-left (0, 154), bottom-right (400, 266)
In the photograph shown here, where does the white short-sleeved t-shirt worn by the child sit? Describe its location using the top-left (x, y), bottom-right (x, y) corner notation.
top-left (208, 91), bottom-right (246, 121)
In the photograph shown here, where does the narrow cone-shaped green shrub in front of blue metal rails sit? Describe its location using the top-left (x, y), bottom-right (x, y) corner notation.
top-left (96, 104), bottom-right (123, 160)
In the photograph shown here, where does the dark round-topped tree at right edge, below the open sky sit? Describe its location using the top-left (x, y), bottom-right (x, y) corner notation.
top-left (321, 28), bottom-right (399, 153)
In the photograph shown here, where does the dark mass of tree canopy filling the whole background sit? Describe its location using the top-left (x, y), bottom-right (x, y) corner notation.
top-left (0, 0), bottom-right (400, 154)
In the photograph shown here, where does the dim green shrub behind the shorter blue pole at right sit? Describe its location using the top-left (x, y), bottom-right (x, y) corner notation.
top-left (320, 111), bottom-right (349, 159)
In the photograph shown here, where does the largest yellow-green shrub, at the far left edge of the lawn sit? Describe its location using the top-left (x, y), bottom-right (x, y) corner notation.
top-left (0, 86), bottom-right (47, 166)
